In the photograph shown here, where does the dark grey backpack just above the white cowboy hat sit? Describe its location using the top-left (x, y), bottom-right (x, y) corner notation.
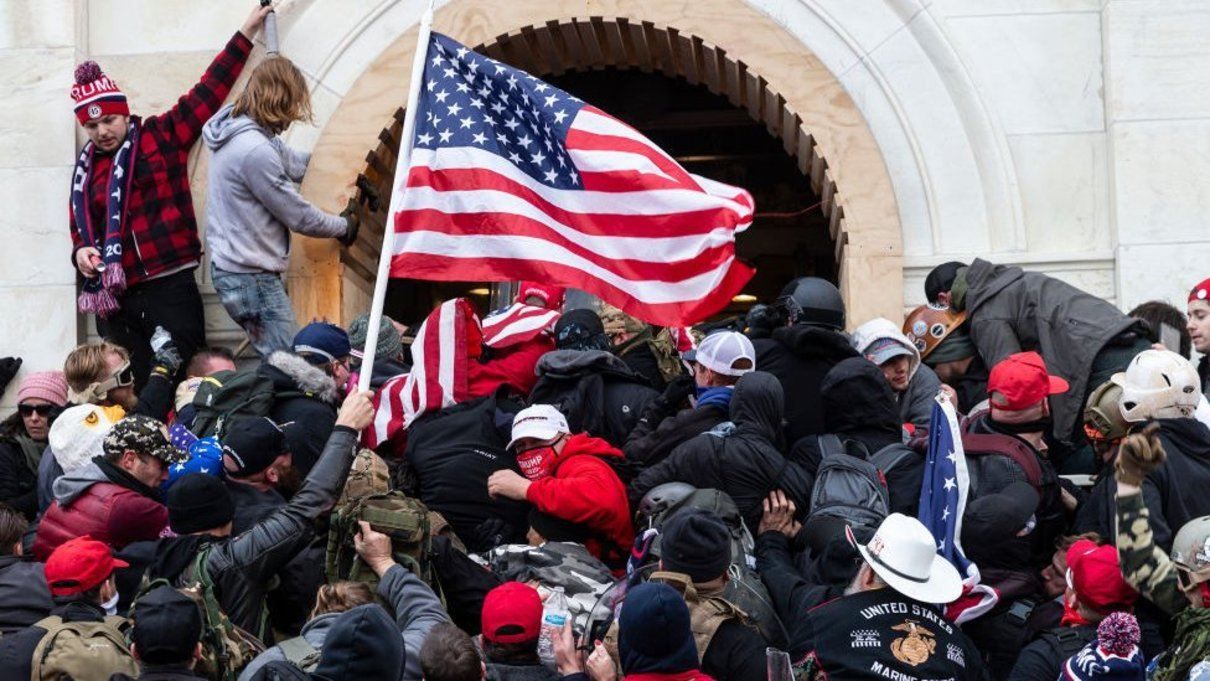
top-left (806, 434), bottom-right (918, 537)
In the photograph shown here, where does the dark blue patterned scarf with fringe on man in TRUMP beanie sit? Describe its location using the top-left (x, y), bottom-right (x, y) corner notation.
top-left (71, 119), bottom-right (139, 317)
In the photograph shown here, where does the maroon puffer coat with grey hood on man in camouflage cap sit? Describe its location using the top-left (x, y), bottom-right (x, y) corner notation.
top-left (34, 456), bottom-right (168, 561)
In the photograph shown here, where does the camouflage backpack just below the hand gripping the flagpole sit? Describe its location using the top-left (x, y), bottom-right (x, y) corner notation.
top-left (325, 491), bottom-right (444, 600)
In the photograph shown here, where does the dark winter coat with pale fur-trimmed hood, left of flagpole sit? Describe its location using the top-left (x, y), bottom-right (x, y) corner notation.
top-left (257, 351), bottom-right (340, 475)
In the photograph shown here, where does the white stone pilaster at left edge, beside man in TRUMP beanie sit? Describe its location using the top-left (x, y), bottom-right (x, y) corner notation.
top-left (0, 0), bottom-right (76, 404)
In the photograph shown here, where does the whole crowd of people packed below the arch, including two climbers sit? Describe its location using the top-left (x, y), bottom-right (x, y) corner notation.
top-left (7, 2), bottom-right (1210, 681)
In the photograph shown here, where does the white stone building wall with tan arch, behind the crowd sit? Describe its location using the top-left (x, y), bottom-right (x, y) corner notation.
top-left (0, 0), bottom-right (1210, 404)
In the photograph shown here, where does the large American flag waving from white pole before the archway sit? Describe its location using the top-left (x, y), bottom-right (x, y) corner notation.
top-left (391, 33), bottom-right (754, 327)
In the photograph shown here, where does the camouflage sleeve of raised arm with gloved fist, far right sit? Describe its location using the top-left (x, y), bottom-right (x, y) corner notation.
top-left (1116, 492), bottom-right (1189, 614)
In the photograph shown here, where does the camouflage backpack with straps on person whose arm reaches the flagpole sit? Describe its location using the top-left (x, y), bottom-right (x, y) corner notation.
top-left (131, 544), bottom-right (267, 681)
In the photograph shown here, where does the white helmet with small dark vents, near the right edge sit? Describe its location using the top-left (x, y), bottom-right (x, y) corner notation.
top-left (1111, 350), bottom-right (1202, 423)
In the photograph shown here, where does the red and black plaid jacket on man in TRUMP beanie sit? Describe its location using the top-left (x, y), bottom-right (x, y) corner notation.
top-left (68, 33), bottom-right (252, 285)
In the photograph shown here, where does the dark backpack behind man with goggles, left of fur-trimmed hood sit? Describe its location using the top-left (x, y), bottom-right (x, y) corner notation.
top-left (192, 369), bottom-right (306, 439)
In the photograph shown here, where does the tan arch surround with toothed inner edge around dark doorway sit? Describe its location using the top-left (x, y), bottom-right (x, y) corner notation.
top-left (290, 0), bottom-right (903, 329)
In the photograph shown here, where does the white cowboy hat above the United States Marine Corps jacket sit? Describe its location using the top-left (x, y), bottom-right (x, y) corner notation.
top-left (846, 513), bottom-right (962, 604)
